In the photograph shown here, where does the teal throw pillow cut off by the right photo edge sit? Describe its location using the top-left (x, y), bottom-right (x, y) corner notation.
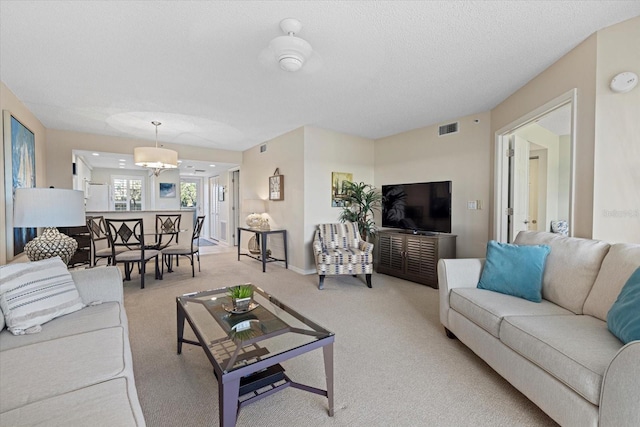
top-left (607, 268), bottom-right (640, 344)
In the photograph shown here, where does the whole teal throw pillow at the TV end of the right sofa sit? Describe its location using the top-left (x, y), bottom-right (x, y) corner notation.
top-left (478, 240), bottom-right (551, 302)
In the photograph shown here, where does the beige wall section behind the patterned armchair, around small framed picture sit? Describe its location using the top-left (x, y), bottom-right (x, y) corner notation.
top-left (302, 126), bottom-right (379, 273)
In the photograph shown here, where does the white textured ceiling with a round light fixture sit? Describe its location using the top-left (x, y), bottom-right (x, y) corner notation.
top-left (0, 0), bottom-right (640, 150)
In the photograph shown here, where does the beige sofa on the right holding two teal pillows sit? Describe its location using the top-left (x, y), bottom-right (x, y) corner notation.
top-left (438, 232), bottom-right (640, 427)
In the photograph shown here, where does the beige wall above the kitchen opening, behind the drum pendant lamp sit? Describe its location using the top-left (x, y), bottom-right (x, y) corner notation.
top-left (46, 129), bottom-right (242, 188)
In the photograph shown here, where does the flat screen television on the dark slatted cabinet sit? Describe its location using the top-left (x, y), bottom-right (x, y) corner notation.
top-left (382, 181), bottom-right (451, 233)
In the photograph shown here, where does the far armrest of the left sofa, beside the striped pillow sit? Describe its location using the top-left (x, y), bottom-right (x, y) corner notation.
top-left (71, 267), bottom-right (123, 304)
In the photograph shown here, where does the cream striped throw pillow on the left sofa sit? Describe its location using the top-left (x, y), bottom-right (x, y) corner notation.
top-left (0, 257), bottom-right (84, 335)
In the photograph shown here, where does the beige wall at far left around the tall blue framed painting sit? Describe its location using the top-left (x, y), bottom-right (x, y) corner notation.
top-left (0, 82), bottom-right (49, 264)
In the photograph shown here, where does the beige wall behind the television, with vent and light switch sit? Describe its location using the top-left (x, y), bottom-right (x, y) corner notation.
top-left (375, 112), bottom-right (492, 258)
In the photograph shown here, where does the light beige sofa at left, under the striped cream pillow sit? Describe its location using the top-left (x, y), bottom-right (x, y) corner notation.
top-left (0, 267), bottom-right (145, 426)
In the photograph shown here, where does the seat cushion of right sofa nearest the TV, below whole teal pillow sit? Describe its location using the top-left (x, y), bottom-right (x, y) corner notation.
top-left (449, 288), bottom-right (573, 338)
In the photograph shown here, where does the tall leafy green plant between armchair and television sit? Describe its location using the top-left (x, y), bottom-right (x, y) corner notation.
top-left (339, 181), bottom-right (382, 240)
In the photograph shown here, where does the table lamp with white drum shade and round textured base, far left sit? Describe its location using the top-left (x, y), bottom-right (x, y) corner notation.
top-left (13, 188), bottom-right (86, 264)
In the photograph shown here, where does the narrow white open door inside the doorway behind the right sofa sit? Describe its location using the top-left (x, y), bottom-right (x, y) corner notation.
top-left (509, 135), bottom-right (529, 242)
